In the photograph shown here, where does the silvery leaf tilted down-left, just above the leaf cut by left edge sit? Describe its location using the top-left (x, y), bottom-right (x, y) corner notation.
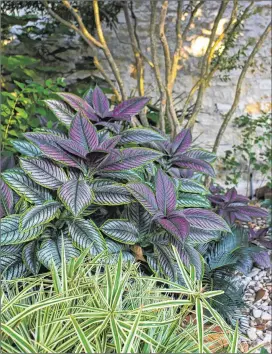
top-left (20, 202), bottom-right (61, 231)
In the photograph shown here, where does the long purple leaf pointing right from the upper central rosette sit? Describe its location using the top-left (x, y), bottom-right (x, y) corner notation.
top-left (100, 148), bottom-right (161, 171)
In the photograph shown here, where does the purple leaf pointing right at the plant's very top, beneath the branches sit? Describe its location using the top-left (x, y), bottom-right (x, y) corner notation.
top-left (111, 97), bottom-right (150, 119)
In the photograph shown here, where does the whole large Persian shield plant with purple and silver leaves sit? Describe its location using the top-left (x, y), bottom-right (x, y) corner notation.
top-left (1, 87), bottom-right (232, 278)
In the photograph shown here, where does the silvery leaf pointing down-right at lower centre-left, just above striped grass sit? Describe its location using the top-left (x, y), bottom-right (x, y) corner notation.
top-left (69, 219), bottom-right (106, 255)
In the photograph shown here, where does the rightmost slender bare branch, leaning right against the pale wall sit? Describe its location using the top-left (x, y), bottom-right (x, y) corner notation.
top-left (213, 22), bottom-right (271, 153)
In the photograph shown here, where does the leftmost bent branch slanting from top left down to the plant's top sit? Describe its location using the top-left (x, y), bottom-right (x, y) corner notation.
top-left (43, 0), bottom-right (121, 101)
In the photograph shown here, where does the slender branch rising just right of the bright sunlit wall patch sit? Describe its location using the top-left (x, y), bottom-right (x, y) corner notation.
top-left (187, 0), bottom-right (229, 129)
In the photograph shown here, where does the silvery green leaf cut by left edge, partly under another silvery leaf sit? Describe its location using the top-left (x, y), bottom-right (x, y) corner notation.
top-left (1, 215), bottom-right (43, 246)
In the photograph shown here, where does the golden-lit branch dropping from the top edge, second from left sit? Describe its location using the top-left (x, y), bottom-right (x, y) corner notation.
top-left (93, 0), bottom-right (126, 100)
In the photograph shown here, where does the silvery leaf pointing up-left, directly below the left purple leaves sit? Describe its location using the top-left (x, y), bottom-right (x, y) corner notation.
top-left (20, 158), bottom-right (68, 189)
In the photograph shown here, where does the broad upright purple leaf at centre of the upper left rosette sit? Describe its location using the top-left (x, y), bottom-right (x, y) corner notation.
top-left (69, 114), bottom-right (98, 151)
